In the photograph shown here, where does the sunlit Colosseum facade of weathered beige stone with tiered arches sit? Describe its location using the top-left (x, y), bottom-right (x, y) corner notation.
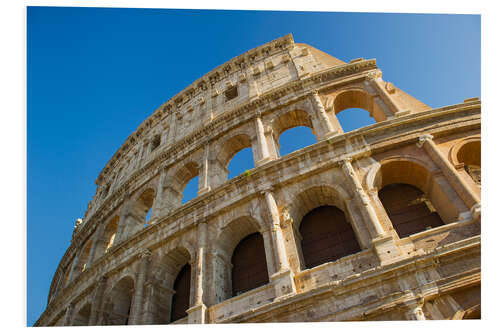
top-left (35, 35), bottom-right (481, 326)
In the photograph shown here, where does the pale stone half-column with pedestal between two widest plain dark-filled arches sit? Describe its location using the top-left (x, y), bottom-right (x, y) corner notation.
top-left (261, 189), bottom-right (296, 299)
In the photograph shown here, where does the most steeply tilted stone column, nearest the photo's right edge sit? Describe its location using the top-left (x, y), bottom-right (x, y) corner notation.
top-left (417, 134), bottom-right (481, 210)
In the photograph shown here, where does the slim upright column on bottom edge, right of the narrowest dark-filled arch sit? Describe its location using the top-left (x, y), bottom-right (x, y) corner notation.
top-left (186, 220), bottom-right (208, 324)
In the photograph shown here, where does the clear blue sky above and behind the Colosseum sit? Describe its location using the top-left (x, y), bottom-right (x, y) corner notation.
top-left (27, 7), bottom-right (480, 326)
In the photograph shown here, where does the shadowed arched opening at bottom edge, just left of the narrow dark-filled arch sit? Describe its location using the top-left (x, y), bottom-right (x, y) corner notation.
top-left (102, 277), bottom-right (134, 325)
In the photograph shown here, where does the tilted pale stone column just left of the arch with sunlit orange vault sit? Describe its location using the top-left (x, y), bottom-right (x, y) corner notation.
top-left (340, 158), bottom-right (386, 238)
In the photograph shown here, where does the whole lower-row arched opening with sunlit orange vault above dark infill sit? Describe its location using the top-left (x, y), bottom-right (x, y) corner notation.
top-left (375, 160), bottom-right (459, 238)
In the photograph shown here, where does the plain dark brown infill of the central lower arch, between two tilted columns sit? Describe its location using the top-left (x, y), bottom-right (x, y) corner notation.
top-left (299, 206), bottom-right (361, 268)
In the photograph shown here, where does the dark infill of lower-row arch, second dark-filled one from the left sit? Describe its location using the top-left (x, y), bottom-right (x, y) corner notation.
top-left (231, 232), bottom-right (269, 296)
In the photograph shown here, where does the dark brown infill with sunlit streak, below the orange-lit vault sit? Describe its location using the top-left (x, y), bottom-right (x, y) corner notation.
top-left (378, 183), bottom-right (444, 238)
